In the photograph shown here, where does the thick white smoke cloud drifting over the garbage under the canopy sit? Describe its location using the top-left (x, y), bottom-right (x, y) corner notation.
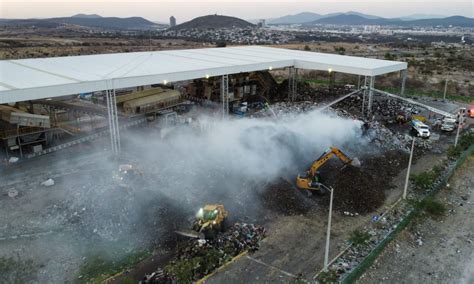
top-left (125, 108), bottom-right (361, 202)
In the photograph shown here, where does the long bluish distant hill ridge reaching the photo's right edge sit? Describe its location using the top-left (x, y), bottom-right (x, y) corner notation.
top-left (304, 15), bottom-right (474, 27)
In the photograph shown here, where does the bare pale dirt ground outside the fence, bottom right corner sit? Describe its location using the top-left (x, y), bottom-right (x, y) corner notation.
top-left (358, 156), bottom-right (474, 283)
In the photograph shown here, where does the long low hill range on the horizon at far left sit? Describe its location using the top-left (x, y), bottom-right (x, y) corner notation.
top-left (0, 14), bottom-right (157, 30)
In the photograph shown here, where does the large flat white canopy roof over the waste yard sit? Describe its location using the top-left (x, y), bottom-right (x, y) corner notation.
top-left (0, 46), bottom-right (407, 103)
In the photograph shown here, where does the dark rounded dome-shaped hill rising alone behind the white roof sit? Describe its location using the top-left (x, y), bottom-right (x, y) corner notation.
top-left (170, 15), bottom-right (255, 30)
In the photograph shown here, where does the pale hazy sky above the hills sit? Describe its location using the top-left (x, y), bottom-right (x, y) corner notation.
top-left (0, 0), bottom-right (474, 23)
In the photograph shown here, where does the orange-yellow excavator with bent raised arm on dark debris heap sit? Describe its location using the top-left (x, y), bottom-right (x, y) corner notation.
top-left (296, 147), bottom-right (360, 190)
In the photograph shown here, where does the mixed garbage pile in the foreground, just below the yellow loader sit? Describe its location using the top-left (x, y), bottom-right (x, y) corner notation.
top-left (141, 223), bottom-right (266, 283)
